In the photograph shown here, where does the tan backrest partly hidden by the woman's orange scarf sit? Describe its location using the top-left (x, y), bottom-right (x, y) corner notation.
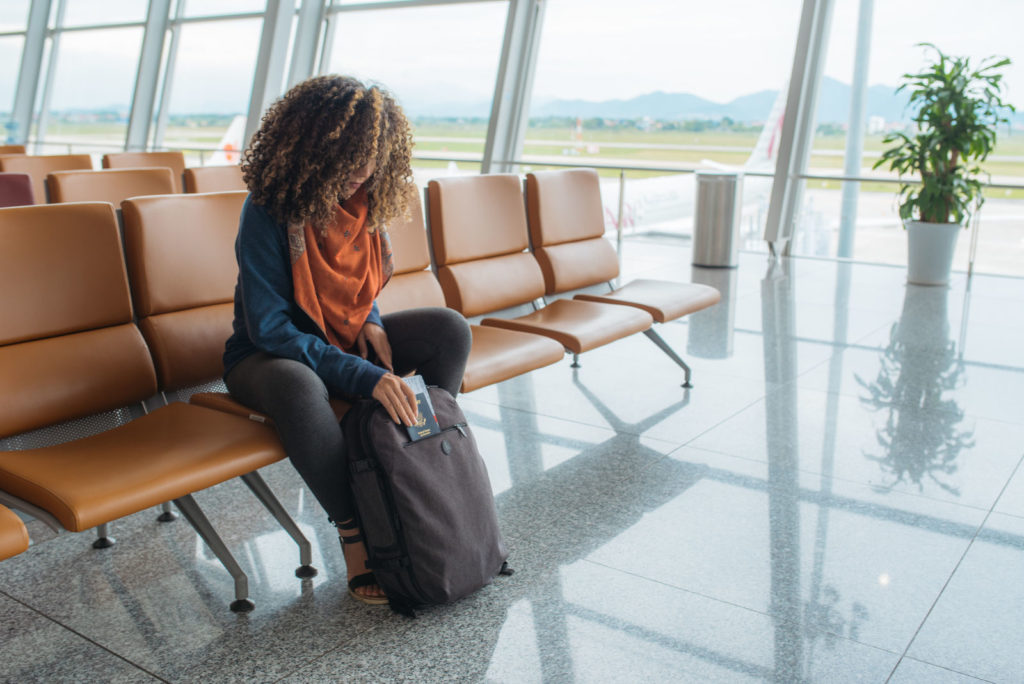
top-left (377, 192), bottom-right (444, 313)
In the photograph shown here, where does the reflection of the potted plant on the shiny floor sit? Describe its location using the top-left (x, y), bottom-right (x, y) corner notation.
top-left (857, 285), bottom-right (974, 496)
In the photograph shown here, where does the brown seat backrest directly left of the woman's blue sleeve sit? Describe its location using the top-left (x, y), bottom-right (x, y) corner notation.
top-left (122, 191), bottom-right (247, 390)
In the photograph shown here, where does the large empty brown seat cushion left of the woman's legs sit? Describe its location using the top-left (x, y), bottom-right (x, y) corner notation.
top-left (0, 402), bottom-right (285, 531)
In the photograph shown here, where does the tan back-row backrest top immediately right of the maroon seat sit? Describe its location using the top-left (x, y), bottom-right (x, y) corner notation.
top-left (46, 167), bottom-right (174, 208)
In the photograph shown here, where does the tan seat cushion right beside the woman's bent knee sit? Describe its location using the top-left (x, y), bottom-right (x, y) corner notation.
top-left (462, 326), bottom-right (565, 392)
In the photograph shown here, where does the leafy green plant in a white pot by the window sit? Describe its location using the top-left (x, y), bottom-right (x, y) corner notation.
top-left (872, 43), bottom-right (1014, 285)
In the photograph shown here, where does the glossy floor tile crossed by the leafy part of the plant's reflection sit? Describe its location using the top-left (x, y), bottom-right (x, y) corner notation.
top-left (689, 385), bottom-right (1024, 510)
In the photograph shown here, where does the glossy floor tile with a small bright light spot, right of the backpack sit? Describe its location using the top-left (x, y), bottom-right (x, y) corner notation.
top-left (544, 455), bottom-right (981, 652)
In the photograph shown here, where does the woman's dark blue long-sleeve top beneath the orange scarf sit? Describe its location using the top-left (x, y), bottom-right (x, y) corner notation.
top-left (224, 197), bottom-right (387, 396)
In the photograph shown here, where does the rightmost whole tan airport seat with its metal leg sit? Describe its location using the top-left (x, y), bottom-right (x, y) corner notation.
top-left (525, 169), bottom-right (722, 387)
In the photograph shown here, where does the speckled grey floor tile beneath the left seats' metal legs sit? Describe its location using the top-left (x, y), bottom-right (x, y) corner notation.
top-left (0, 475), bottom-right (389, 681)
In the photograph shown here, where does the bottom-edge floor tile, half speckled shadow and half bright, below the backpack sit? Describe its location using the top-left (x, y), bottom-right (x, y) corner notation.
top-left (288, 532), bottom-right (898, 682)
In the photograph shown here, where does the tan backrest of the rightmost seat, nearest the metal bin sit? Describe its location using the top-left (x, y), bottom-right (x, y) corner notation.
top-left (525, 169), bottom-right (618, 294)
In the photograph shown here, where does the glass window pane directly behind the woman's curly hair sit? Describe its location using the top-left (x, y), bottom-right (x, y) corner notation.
top-left (328, 2), bottom-right (508, 185)
